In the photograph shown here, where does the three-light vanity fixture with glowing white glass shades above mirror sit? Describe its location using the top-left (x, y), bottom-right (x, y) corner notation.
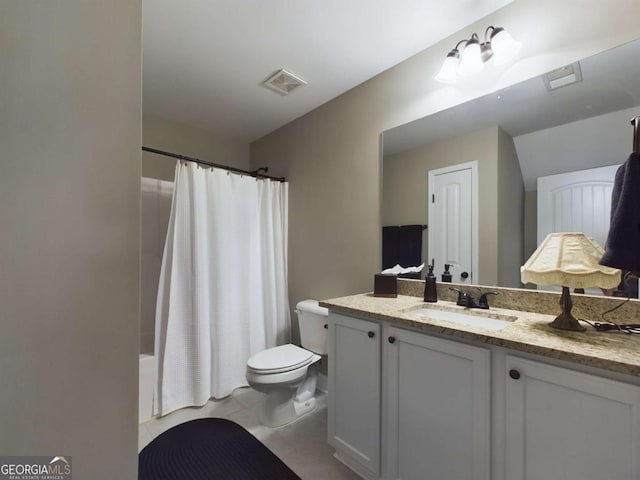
top-left (435, 25), bottom-right (522, 83)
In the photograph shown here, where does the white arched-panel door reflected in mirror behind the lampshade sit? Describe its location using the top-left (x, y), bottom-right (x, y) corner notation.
top-left (538, 165), bottom-right (619, 247)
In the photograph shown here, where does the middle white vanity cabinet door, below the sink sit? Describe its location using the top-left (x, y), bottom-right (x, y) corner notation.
top-left (383, 327), bottom-right (491, 480)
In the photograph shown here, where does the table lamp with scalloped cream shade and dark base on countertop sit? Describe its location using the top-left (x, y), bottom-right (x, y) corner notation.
top-left (520, 233), bottom-right (620, 332)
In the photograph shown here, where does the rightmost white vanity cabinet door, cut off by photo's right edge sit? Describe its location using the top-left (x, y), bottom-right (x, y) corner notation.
top-left (504, 355), bottom-right (640, 480)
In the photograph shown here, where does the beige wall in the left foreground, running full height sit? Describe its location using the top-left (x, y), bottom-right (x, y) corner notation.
top-left (0, 0), bottom-right (142, 480)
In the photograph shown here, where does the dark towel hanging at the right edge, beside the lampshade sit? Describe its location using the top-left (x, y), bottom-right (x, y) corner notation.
top-left (600, 153), bottom-right (640, 271)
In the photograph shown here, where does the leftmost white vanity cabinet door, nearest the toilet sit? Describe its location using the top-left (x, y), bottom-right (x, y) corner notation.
top-left (327, 312), bottom-right (381, 478)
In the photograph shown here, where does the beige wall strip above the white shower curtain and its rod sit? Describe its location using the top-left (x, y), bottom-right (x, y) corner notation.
top-left (142, 113), bottom-right (249, 181)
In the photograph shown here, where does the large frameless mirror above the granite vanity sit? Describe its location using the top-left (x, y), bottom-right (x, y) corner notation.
top-left (381, 40), bottom-right (640, 287)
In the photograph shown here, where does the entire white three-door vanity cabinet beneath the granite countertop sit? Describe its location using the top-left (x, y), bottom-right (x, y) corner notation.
top-left (328, 310), bottom-right (640, 480)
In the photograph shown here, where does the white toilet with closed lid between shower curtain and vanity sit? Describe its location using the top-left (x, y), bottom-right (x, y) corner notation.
top-left (246, 300), bottom-right (329, 427)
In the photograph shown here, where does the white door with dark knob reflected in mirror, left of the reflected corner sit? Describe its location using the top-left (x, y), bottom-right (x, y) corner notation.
top-left (427, 162), bottom-right (478, 283)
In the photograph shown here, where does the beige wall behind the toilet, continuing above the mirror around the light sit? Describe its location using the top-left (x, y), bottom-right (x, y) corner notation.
top-left (251, 0), bottom-right (640, 303)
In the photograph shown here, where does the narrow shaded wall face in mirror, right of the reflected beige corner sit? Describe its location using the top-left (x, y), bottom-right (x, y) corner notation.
top-left (496, 128), bottom-right (524, 287)
